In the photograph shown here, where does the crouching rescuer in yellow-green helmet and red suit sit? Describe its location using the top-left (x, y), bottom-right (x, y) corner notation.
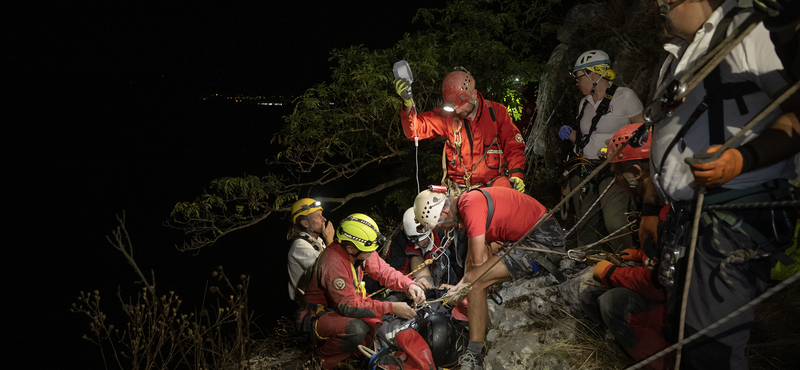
top-left (305, 213), bottom-right (430, 369)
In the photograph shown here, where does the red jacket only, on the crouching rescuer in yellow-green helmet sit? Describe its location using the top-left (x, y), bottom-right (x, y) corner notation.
top-left (305, 242), bottom-right (415, 318)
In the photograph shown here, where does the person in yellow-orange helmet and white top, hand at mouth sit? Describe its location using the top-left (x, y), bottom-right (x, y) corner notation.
top-left (286, 198), bottom-right (333, 302)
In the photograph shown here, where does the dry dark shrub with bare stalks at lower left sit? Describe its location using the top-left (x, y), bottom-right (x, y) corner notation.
top-left (71, 214), bottom-right (255, 370)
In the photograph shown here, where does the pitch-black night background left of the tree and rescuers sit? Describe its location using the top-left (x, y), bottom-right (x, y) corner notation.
top-left (9, 1), bottom-right (444, 369)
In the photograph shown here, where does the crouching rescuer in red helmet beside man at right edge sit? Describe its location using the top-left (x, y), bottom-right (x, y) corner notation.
top-left (580, 123), bottom-right (674, 369)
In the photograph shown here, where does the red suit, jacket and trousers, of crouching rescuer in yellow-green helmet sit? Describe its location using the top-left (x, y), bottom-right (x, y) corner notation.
top-left (305, 243), bottom-right (415, 369)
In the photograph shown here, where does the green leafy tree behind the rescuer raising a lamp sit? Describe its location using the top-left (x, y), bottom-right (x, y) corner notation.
top-left (168, 0), bottom-right (559, 250)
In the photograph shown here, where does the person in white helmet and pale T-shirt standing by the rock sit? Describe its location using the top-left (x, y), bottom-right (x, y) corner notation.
top-left (558, 50), bottom-right (644, 251)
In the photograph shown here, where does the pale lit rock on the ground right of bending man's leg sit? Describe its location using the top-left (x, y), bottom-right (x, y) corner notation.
top-left (484, 266), bottom-right (592, 370)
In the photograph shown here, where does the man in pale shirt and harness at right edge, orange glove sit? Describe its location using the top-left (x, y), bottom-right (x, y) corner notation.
top-left (651, 0), bottom-right (800, 369)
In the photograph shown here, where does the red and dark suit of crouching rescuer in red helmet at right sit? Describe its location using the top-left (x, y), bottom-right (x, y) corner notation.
top-left (581, 265), bottom-right (674, 369)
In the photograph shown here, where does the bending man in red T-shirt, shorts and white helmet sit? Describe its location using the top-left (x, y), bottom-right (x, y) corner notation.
top-left (414, 187), bottom-right (565, 370)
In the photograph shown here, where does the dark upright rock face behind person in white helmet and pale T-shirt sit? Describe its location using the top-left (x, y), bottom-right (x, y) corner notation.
top-left (526, 0), bottom-right (666, 188)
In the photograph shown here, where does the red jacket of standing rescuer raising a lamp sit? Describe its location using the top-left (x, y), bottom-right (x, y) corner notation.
top-left (400, 93), bottom-right (525, 188)
